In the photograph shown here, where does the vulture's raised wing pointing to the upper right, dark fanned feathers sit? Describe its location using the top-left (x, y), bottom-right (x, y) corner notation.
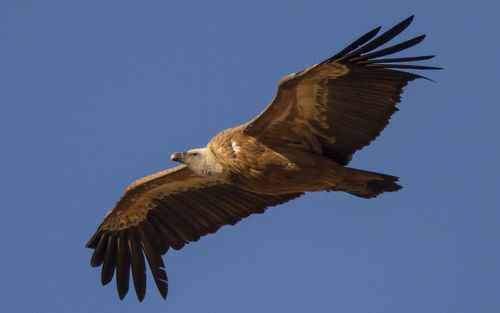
top-left (244, 16), bottom-right (439, 165)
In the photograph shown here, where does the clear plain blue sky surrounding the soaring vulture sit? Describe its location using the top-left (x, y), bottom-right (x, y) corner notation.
top-left (0, 0), bottom-right (500, 313)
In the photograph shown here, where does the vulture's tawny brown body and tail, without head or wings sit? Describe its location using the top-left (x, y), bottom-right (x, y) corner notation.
top-left (207, 125), bottom-right (401, 198)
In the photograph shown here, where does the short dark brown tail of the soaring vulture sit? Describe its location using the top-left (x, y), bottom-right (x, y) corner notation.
top-left (332, 167), bottom-right (403, 199)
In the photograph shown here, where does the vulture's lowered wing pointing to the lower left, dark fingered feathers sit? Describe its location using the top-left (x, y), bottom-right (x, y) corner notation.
top-left (86, 165), bottom-right (301, 301)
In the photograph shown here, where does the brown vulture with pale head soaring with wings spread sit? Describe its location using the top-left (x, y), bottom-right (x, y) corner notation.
top-left (86, 16), bottom-right (440, 301)
